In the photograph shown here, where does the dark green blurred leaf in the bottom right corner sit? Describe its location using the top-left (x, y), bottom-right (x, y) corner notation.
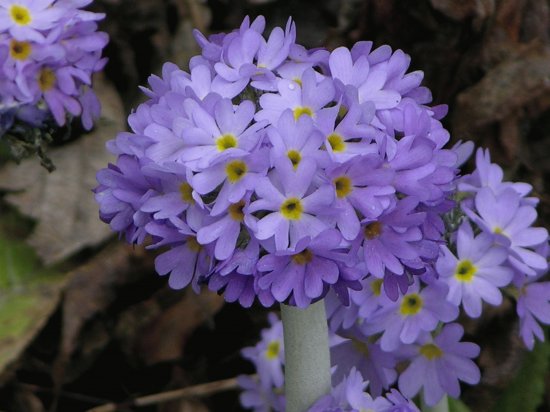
top-left (492, 341), bottom-right (550, 412)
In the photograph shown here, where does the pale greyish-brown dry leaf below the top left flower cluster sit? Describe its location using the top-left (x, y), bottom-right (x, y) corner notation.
top-left (0, 77), bottom-right (125, 264)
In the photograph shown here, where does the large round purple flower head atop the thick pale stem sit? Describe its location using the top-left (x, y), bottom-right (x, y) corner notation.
top-left (95, 17), bottom-right (466, 307)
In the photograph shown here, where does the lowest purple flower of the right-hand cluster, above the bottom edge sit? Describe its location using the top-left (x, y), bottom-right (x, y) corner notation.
top-left (398, 323), bottom-right (480, 406)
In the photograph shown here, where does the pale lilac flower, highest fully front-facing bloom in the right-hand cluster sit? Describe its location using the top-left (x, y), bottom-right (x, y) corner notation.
top-left (436, 222), bottom-right (513, 318)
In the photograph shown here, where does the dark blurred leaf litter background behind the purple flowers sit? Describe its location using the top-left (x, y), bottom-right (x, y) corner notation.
top-left (0, 0), bottom-right (550, 412)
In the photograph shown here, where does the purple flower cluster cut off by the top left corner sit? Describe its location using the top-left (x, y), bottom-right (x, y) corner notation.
top-left (0, 0), bottom-right (108, 136)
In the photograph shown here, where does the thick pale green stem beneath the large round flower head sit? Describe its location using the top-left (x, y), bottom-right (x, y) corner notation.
top-left (281, 300), bottom-right (330, 412)
